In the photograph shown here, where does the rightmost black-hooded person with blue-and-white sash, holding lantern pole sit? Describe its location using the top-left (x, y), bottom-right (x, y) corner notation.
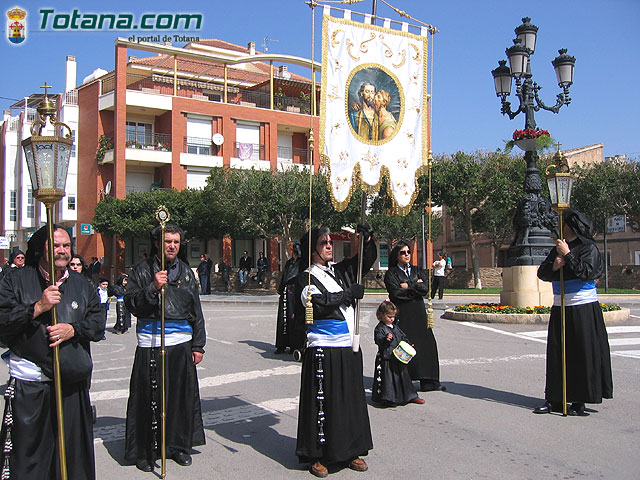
top-left (534, 209), bottom-right (613, 416)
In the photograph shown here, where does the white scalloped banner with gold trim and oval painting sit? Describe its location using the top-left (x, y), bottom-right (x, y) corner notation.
top-left (320, 8), bottom-right (429, 215)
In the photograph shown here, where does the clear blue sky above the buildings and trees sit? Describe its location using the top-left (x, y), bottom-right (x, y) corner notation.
top-left (0, 0), bottom-right (640, 159)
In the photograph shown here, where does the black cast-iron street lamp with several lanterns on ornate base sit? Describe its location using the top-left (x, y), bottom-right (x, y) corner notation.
top-left (491, 17), bottom-right (576, 267)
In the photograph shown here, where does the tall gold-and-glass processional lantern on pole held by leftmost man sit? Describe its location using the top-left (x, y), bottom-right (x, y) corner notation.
top-left (22, 82), bottom-right (73, 480)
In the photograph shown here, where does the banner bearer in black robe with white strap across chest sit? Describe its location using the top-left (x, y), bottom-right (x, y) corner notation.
top-left (295, 225), bottom-right (377, 477)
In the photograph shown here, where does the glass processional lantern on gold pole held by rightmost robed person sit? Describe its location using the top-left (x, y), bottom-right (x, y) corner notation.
top-left (544, 145), bottom-right (573, 415)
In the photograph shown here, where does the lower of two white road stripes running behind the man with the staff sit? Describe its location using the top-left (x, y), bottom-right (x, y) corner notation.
top-left (93, 397), bottom-right (298, 445)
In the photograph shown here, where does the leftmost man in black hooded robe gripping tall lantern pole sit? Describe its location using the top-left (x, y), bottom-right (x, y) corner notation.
top-left (0, 225), bottom-right (105, 480)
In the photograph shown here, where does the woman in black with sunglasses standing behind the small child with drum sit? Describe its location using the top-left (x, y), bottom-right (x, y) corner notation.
top-left (384, 240), bottom-right (445, 392)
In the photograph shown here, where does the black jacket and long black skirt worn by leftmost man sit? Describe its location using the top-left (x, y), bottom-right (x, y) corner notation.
top-left (0, 249), bottom-right (105, 480)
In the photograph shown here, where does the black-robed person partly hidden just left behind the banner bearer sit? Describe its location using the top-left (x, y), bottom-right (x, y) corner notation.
top-left (276, 241), bottom-right (300, 353)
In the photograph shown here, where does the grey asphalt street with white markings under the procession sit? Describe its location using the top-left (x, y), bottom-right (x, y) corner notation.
top-left (0, 295), bottom-right (640, 480)
